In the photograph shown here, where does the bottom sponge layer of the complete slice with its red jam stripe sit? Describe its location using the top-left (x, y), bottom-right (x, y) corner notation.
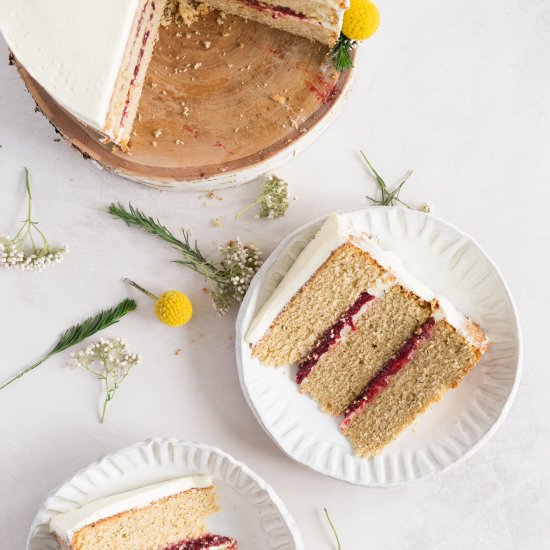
top-left (341, 311), bottom-right (488, 456)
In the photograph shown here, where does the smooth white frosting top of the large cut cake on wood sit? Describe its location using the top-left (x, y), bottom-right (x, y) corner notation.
top-left (0, 0), bottom-right (141, 131)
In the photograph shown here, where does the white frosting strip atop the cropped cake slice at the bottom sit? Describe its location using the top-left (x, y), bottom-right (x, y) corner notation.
top-left (50, 476), bottom-right (212, 541)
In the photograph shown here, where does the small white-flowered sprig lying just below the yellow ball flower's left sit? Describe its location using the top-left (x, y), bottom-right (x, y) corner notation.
top-left (71, 338), bottom-right (141, 424)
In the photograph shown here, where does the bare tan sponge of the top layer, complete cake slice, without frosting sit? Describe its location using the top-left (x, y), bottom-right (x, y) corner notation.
top-left (252, 243), bottom-right (387, 366)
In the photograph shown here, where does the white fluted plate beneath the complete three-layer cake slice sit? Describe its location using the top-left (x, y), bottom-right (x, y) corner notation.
top-left (236, 207), bottom-right (521, 486)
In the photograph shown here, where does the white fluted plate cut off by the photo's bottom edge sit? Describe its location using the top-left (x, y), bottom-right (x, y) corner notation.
top-left (27, 438), bottom-right (304, 550)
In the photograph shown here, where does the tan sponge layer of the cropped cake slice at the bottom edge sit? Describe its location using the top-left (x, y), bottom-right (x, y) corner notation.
top-left (68, 486), bottom-right (218, 550)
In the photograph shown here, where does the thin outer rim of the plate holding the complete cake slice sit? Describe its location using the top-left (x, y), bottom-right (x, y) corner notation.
top-left (235, 206), bottom-right (523, 488)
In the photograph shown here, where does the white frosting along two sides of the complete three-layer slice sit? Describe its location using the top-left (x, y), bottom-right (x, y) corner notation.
top-left (245, 214), bottom-right (484, 344)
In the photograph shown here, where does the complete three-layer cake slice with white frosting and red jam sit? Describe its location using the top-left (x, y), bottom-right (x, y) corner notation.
top-left (246, 214), bottom-right (489, 456)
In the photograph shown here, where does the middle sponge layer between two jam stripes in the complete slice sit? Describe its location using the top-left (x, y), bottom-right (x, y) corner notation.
top-left (300, 285), bottom-right (432, 415)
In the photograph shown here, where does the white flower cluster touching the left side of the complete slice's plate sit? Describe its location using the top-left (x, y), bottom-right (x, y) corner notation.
top-left (214, 238), bottom-right (262, 315)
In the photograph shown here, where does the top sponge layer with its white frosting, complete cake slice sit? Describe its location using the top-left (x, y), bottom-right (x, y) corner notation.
top-left (246, 214), bottom-right (394, 366)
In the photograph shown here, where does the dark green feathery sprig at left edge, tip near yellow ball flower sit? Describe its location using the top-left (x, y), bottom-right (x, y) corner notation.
top-left (0, 298), bottom-right (137, 390)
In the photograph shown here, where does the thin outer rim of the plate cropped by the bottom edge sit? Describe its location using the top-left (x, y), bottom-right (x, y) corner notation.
top-left (25, 437), bottom-right (305, 550)
